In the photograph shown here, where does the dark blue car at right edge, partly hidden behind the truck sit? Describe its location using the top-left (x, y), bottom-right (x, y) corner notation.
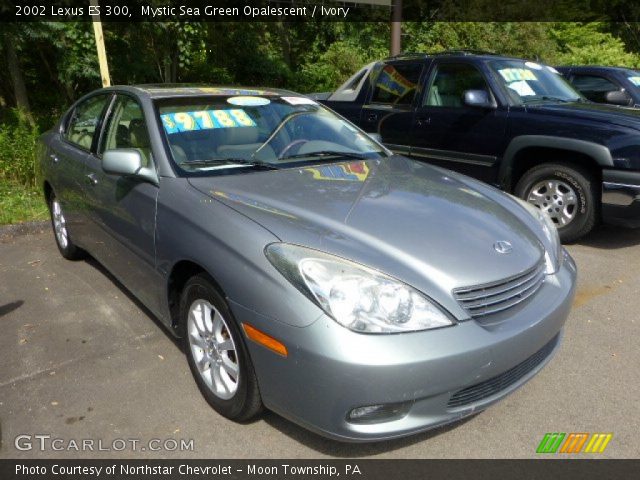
top-left (556, 66), bottom-right (640, 107)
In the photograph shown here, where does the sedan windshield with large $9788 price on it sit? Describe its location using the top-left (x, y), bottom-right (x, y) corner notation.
top-left (158, 95), bottom-right (387, 175)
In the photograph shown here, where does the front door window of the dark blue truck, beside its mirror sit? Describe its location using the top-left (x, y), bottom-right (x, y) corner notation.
top-left (424, 63), bottom-right (489, 107)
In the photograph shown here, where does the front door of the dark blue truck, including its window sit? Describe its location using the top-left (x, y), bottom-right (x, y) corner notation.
top-left (411, 60), bottom-right (508, 182)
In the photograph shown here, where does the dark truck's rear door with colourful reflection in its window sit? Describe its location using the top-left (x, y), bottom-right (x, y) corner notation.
top-left (360, 60), bottom-right (425, 154)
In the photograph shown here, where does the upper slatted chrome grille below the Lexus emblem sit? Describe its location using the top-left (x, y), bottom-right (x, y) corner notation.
top-left (453, 262), bottom-right (544, 318)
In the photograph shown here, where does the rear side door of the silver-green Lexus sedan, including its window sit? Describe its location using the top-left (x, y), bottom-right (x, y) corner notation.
top-left (48, 94), bottom-right (110, 247)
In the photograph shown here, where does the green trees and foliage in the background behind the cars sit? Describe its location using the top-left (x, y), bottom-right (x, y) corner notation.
top-left (0, 21), bottom-right (640, 126)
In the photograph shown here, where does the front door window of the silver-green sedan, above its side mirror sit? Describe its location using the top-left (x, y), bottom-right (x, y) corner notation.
top-left (101, 95), bottom-right (151, 167)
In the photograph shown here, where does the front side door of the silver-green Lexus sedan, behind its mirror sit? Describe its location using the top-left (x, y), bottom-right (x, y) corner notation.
top-left (85, 93), bottom-right (161, 310)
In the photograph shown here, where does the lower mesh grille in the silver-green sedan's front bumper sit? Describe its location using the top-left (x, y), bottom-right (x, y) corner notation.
top-left (447, 335), bottom-right (559, 409)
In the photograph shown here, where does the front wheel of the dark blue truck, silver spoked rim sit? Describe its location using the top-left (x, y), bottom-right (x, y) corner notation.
top-left (515, 163), bottom-right (600, 243)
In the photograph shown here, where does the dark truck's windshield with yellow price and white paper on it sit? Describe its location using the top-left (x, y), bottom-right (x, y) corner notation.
top-left (489, 60), bottom-right (584, 104)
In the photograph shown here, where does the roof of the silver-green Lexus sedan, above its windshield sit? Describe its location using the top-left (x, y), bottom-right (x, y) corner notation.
top-left (104, 83), bottom-right (302, 99)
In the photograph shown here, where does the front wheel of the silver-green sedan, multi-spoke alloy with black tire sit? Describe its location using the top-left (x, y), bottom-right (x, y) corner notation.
top-left (180, 274), bottom-right (262, 422)
